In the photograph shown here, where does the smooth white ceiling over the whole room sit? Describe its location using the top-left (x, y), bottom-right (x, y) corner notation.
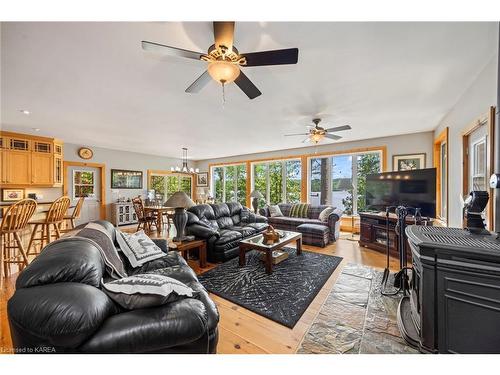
top-left (1, 22), bottom-right (497, 159)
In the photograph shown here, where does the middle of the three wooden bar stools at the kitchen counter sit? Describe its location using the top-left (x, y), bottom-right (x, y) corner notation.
top-left (28, 196), bottom-right (71, 255)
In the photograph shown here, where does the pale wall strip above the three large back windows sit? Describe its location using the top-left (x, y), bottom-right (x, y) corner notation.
top-left (196, 132), bottom-right (433, 172)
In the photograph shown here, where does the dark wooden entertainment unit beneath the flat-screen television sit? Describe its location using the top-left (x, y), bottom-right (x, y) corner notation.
top-left (359, 212), bottom-right (433, 257)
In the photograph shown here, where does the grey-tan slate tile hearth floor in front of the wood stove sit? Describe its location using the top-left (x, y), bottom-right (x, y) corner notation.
top-left (297, 263), bottom-right (418, 354)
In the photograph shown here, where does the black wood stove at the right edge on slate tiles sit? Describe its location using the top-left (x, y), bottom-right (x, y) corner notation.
top-left (398, 225), bottom-right (500, 353)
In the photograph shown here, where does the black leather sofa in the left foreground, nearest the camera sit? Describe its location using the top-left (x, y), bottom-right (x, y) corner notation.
top-left (7, 221), bottom-right (219, 353)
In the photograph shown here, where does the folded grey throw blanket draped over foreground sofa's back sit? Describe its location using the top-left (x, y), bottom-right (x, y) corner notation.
top-left (58, 223), bottom-right (127, 279)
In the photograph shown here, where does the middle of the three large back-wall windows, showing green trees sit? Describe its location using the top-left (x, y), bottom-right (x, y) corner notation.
top-left (253, 159), bottom-right (302, 205)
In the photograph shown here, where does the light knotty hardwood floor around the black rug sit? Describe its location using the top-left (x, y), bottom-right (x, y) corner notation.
top-left (0, 227), bottom-right (398, 354)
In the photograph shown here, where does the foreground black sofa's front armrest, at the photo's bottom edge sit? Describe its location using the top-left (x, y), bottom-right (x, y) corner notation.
top-left (80, 298), bottom-right (209, 353)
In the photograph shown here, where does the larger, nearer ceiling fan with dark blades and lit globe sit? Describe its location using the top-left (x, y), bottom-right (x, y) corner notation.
top-left (142, 22), bottom-right (299, 99)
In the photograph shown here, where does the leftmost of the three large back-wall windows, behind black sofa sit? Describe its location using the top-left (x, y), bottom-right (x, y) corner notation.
top-left (211, 164), bottom-right (247, 205)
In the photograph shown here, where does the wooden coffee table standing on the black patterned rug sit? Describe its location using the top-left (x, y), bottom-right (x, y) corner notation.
top-left (239, 230), bottom-right (302, 274)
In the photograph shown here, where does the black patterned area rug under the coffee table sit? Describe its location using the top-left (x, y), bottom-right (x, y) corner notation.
top-left (199, 248), bottom-right (342, 328)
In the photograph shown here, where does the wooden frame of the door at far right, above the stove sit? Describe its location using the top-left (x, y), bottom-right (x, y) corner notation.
top-left (462, 106), bottom-right (496, 230)
